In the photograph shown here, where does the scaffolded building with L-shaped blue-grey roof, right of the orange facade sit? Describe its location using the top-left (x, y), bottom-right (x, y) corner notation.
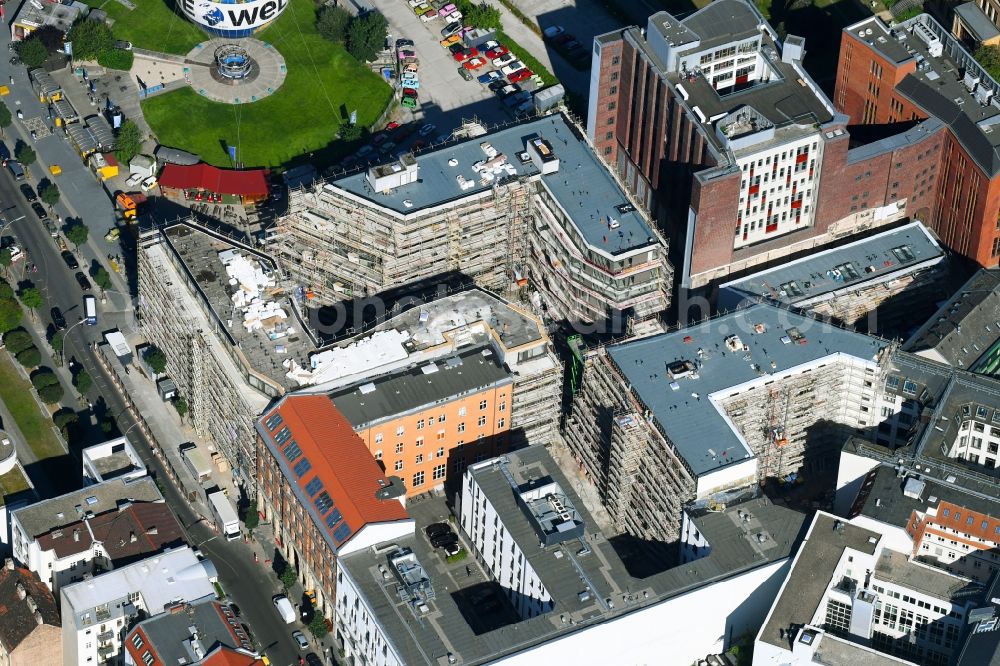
top-left (564, 304), bottom-right (893, 543)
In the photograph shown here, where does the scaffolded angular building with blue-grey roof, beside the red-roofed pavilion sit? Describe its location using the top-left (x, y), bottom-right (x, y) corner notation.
top-left (268, 114), bottom-right (672, 330)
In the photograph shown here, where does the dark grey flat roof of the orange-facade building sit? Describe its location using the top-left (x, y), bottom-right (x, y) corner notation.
top-left (330, 347), bottom-right (513, 426)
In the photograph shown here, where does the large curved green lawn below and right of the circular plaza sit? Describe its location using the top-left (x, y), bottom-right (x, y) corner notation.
top-left (142, 0), bottom-right (392, 167)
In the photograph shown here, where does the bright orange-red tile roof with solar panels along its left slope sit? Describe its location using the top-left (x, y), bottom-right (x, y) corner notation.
top-left (260, 395), bottom-right (409, 547)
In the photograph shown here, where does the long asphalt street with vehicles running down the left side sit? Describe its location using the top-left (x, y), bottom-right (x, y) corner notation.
top-left (0, 59), bottom-right (302, 666)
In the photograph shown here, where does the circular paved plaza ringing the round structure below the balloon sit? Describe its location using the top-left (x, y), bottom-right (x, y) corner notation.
top-left (184, 39), bottom-right (287, 104)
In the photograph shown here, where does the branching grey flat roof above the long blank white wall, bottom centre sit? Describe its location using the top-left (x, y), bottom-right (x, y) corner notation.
top-left (339, 446), bottom-right (806, 666)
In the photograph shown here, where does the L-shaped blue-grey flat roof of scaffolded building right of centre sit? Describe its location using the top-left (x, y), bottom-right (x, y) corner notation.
top-left (607, 304), bottom-right (887, 475)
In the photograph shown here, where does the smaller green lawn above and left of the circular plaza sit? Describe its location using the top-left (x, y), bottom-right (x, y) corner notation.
top-left (99, 0), bottom-right (208, 55)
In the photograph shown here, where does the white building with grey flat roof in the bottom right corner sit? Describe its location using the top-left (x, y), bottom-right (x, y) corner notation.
top-left (753, 512), bottom-right (972, 666)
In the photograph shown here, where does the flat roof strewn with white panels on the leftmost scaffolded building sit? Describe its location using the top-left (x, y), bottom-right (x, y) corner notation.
top-left (164, 224), bottom-right (313, 389)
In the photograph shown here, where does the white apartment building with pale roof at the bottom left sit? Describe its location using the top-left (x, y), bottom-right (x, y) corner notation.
top-left (60, 546), bottom-right (218, 666)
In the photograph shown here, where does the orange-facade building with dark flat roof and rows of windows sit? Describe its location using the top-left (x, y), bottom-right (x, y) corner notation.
top-left (330, 347), bottom-right (513, 497)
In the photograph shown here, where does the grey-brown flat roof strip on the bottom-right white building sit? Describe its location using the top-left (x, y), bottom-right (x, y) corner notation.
top-left (760, 513), bottom-right (882, 649)
